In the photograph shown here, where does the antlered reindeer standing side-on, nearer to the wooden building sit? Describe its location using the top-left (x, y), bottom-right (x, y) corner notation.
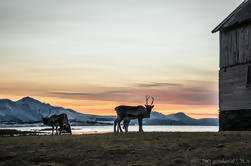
top-left (114, 96), bottom-right (154, 133)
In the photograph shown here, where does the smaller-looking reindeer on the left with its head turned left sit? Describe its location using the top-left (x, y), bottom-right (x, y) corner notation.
top-left (39, 110), bottom-right (72, 135)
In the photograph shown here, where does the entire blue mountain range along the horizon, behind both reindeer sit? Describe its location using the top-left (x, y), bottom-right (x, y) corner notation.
top-left (0, 97), bottom-right (218, 126)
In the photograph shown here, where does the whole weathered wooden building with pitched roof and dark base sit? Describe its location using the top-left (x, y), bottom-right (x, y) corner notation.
top-left (212, 0), bottom-right (251, 131)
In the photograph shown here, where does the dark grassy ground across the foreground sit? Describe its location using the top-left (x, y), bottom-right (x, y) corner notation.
top-left (0, 132), bottom-right (251, 166)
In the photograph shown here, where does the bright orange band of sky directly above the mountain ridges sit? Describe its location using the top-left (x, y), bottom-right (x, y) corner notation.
top-left (0, 95), bottom-right (218, 118)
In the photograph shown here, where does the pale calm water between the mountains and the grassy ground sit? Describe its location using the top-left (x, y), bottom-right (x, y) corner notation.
top-left (1, 126), bottom-right (219, 134)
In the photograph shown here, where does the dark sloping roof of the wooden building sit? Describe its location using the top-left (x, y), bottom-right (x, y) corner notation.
top-left (212, 0), bottom-right (251, 33)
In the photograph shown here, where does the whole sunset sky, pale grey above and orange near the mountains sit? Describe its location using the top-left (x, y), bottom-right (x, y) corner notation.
top-left (0, 0), bottom-right (242, 118)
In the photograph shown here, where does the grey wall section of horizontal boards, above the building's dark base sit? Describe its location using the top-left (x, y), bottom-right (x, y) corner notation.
top-left (219, 64), bottom-right (251, 111)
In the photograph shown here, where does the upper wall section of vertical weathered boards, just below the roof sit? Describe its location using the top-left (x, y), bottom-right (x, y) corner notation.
top-left (220, 24), bottom-right (251, 68)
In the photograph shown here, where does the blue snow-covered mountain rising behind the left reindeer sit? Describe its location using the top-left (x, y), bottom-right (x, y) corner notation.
top-left (0, 97), bottom-right (112, 123)
